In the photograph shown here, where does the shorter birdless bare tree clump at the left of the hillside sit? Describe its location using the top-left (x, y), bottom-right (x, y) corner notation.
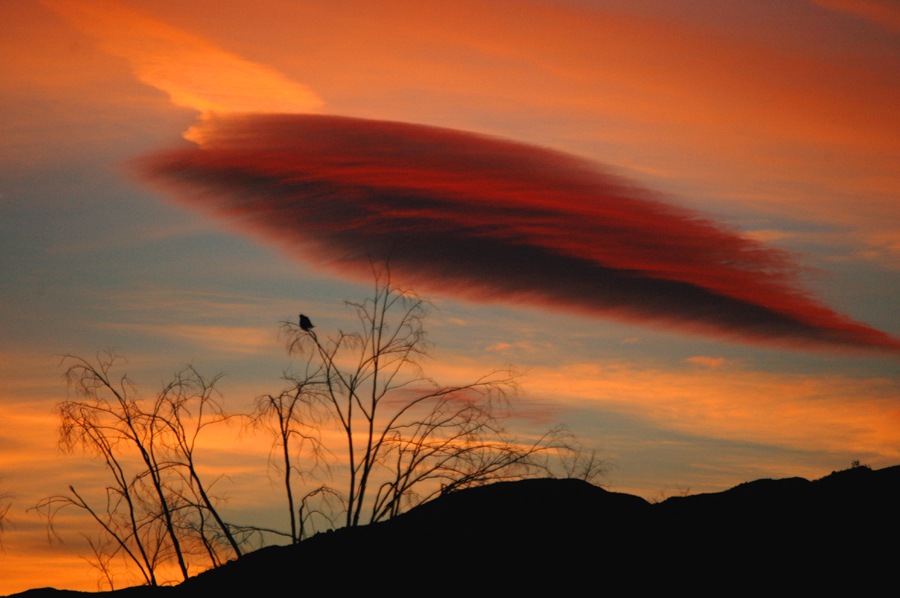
top-left (37, 354), bottom-right (241, 587)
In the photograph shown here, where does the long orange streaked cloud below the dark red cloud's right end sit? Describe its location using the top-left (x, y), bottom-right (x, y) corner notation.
top-left (523, 361), bottom-right (900, 466)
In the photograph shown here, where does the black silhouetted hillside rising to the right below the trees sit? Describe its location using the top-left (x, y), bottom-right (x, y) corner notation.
top-left (8, 466), bottom-right (900, 598)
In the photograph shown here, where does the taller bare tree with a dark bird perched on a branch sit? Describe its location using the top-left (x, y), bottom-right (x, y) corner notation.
top-left (255, 268), bottom-right (565, 537)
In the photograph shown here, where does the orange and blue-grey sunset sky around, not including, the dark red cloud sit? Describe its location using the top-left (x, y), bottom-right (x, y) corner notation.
top-left (0, 0), bottom-right (900, 594)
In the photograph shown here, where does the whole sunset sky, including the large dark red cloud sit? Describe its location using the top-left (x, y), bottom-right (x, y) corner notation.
top-left (0, 0), bottom-right (900, 594)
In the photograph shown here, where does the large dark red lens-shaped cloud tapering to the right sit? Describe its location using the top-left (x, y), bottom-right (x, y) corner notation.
top-left (141, 115), bottom-right (900, 351)
